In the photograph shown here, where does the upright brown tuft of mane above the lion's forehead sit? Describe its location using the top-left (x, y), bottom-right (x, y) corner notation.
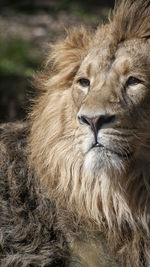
top-left (113, 0), bottom-right (150, 41)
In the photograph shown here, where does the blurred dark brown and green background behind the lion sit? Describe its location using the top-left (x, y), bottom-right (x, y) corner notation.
top-left (0, 0), bottom-right (114, 122)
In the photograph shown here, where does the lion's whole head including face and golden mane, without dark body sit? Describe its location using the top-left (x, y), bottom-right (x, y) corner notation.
top-left (30, 0), bottom-right (150, 231)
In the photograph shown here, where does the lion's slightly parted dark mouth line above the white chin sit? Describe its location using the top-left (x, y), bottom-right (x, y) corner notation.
top-left (90, 142), bottom-right (133, 160)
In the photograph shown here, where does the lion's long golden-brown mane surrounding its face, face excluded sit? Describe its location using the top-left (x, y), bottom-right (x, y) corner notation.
top-left (29, 0), bottom-right (150, 266)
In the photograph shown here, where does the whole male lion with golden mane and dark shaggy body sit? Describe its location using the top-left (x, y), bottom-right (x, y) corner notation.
top-left (0, 0), bottom-right (150, 267)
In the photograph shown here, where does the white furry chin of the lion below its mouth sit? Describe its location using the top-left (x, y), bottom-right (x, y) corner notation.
top-left (84, 146), bottom-right (127, 173)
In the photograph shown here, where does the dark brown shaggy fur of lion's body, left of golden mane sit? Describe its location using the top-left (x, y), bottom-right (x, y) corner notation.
top-left (0, 123), bottom-right (66, 267)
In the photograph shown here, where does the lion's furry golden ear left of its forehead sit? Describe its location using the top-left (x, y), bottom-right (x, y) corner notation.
top-left (43, 27), bottom-right (92, 86)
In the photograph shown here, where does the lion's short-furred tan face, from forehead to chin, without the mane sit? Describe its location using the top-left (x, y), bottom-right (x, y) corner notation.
top-left (72, 40), bottom-right (150, 174)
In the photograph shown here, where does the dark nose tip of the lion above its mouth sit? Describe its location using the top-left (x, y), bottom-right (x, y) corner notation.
top-left (78, 114), bottom-right (115, 133)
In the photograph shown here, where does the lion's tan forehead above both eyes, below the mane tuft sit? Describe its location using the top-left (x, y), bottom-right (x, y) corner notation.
top-left (80, 40), bottom-right (148, 82)
